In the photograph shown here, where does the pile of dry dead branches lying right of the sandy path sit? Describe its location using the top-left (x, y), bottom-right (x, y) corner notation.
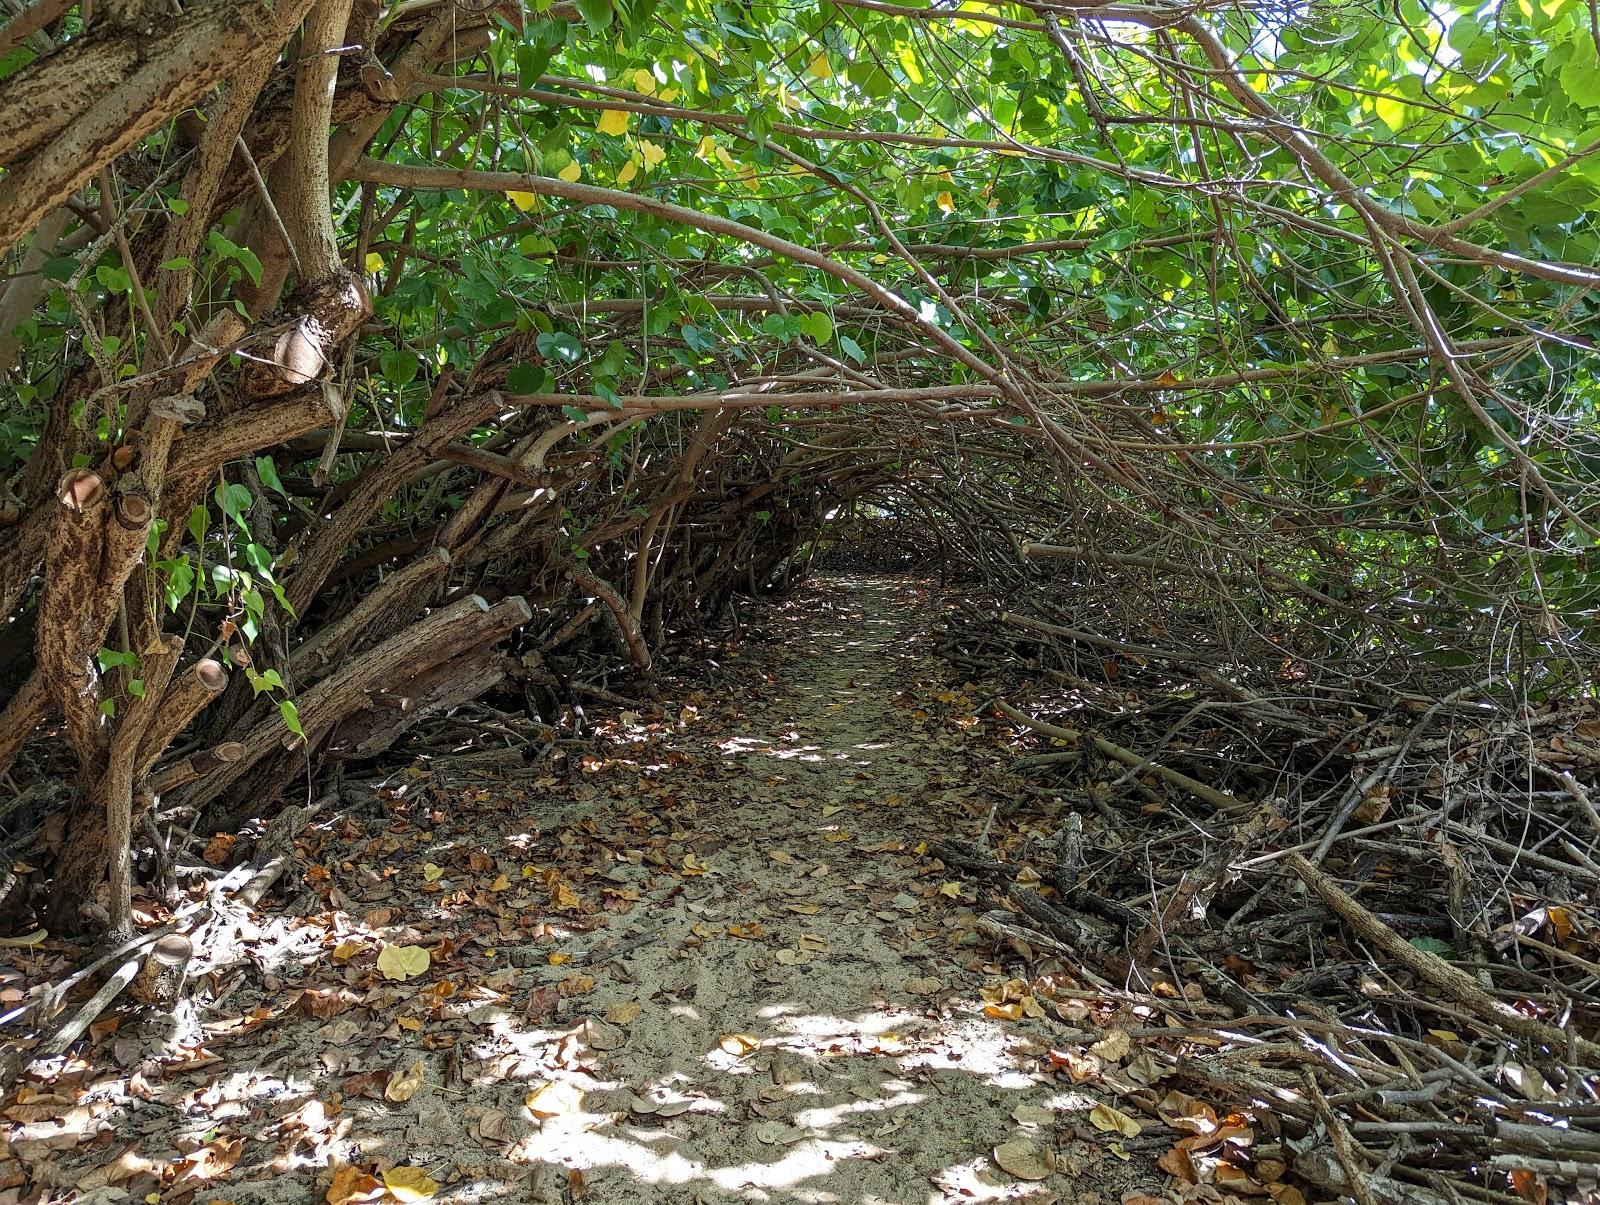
top-left (933, 512), bottom-right (1600, 1203)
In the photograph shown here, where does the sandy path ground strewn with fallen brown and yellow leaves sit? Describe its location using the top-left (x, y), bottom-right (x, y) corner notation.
top-left (3, 579), bottom-right (1163, 1205)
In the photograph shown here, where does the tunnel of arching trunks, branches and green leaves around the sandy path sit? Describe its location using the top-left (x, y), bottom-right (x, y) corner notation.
top-left (0, 0), bottom-right (1600, 1205)
